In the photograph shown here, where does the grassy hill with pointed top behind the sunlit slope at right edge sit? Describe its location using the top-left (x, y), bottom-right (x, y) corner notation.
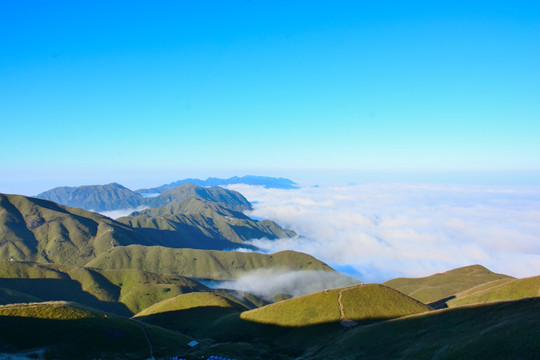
top-left (384, 265), bottom-right (511, 304)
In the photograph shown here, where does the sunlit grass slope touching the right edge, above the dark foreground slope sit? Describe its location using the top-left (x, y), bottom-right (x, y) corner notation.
top-left (448, 276), bottom-right (540, 307)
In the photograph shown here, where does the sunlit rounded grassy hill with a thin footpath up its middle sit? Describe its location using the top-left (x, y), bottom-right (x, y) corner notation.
top-left (240, 284), bottom-right (431, 327)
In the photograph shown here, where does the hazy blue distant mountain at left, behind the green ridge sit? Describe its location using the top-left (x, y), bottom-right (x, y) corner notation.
top-left (36, 183), bottom-right (144, 211)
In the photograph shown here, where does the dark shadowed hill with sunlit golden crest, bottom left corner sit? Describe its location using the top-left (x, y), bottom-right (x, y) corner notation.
top-left (0, 302), bottom-right (191, 359)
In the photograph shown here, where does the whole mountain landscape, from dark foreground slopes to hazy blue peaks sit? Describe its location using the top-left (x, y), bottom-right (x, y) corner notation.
top-left (0, 176), bottom-right (540, 360)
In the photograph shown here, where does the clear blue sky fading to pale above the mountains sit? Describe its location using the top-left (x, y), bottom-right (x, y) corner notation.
top-left (0, 0), bottom-right (540, 194)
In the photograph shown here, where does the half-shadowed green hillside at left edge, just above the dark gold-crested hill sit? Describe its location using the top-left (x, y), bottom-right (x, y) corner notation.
top-left (0, 261), bottom-right (207, 316)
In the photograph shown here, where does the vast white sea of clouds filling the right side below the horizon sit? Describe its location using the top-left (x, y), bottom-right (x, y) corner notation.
top-left (229, 184), bottom-right (540, 282)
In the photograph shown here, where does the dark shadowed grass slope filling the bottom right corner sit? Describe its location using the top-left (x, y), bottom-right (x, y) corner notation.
top-left (308, 298), bottom-right (540, 360)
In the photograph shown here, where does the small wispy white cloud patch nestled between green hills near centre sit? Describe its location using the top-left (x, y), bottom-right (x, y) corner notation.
top-left (211, 269), bottom-right (359, 300)
